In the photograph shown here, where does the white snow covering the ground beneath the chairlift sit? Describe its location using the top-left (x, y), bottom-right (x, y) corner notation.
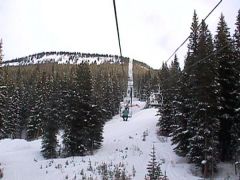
top-left (0, 101), bottom-right (237, 180)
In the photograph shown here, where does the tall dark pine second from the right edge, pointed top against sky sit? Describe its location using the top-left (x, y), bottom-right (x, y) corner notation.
top-left (214, 15), bottom-right (238, 161)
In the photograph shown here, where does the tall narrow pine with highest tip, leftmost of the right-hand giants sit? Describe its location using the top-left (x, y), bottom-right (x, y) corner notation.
top-left (173, 11), bottom-right (199, 156)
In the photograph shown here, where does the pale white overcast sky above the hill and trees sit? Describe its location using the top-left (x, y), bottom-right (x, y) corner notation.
top-left (0, 0), bottom-right (240, 68)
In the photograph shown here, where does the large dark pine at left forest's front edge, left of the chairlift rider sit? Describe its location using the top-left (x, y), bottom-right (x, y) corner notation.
top-left (64, 63), bottom-right (104, 156)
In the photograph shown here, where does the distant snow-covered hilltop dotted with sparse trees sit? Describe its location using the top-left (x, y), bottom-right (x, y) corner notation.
top-left (3, 51), bottom-right (150, 69)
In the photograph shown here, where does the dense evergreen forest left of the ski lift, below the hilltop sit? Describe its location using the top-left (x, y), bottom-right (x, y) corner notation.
top-left (0, 42), bottom-right (154, 158)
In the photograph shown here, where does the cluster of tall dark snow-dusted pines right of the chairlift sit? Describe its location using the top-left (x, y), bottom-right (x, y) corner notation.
top-left (158, 10), bottom-right (240, 177)
